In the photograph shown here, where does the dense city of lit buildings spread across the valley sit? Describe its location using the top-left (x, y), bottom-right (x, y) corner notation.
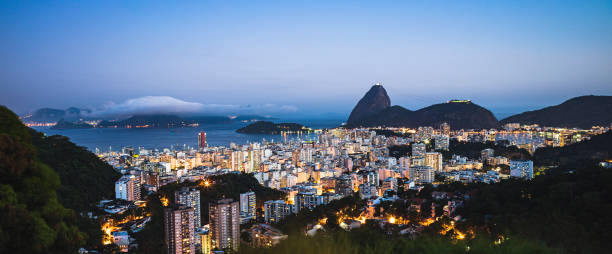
top-left (97, 120), bottom-right (610, 253)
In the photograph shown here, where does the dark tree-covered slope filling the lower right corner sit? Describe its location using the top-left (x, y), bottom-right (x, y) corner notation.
top-left (459, 167), bottom-right (612, 253)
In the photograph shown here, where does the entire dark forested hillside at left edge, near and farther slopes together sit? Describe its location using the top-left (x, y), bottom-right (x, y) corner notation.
top-left (0, 106), bottom-right (119, 253)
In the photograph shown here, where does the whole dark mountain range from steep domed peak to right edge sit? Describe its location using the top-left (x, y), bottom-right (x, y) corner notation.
top-left (346, 84), bottom-right (612, 129)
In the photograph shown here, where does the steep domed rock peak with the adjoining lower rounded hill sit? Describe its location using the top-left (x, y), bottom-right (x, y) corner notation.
top-left (346, 84), bottom-right (499, 129)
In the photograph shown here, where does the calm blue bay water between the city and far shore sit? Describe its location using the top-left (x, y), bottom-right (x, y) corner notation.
top-left (34, 120), bottom-right (342, 151)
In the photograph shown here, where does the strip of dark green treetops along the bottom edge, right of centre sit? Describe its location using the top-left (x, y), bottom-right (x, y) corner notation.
top-left (238, 230), bottom-right (556, 254)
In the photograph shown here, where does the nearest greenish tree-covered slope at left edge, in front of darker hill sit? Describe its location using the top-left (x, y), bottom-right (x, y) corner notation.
top-left (0, 106), bottom-right (87, 253)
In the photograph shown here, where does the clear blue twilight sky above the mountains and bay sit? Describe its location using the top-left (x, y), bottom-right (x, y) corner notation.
top-left (0, 0), bottom-right (612, 116)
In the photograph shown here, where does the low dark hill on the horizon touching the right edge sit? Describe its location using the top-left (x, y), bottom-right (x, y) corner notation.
top-left (501, 95), bottom-right (612, 129)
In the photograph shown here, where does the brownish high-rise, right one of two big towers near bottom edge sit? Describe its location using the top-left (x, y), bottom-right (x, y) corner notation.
top-left (209, 199), bottom-right (240, 251)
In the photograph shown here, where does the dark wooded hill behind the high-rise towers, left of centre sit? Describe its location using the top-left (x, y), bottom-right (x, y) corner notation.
top-left (134, 174), bottom-right (285, 253)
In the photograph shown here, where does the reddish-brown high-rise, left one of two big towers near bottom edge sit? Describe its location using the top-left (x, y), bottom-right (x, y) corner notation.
top-left (164, 206), bottom-right (195, 254)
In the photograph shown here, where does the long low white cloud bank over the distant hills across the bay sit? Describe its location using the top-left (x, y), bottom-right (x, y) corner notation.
top-left (89, 96), bottom-right (298, 118)
